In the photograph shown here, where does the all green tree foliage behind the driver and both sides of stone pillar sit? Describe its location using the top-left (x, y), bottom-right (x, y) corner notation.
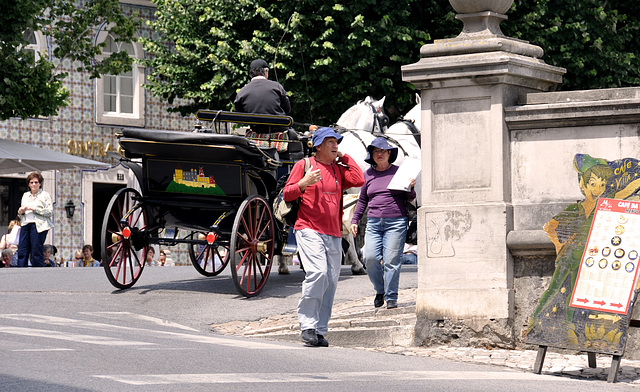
top-left (144, 0), bottom-right (640, 123)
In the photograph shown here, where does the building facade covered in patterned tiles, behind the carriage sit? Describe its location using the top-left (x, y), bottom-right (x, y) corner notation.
top-left (0, 0), bottom-right (195, 262)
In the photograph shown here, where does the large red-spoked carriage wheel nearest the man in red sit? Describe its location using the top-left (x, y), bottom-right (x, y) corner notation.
top-left (229, 195), bottom-right (275, 297)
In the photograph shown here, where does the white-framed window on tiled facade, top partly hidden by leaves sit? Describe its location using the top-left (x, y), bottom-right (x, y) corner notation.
top-left (96, 29), bottom-right (145, 127)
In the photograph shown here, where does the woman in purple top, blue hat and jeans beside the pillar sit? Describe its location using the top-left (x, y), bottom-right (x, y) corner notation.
top-left (351, 137), bottom-right (416, 309)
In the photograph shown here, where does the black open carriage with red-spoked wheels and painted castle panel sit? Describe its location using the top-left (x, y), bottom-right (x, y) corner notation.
top-left (101, 111), bottom-right (306, 297)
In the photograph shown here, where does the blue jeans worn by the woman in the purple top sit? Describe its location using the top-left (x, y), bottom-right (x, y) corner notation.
top-left (364, 217), bottom-right (408, 301)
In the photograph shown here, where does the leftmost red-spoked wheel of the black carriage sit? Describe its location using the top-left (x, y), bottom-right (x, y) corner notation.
top-left (101, 188), bottom-right (148, 289)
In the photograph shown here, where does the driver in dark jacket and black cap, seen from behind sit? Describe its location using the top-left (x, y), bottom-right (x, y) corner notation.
top-left (233, 59), bottom-right (291, 133)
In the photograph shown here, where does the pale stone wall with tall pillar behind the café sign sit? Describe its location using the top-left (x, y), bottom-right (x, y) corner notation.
top-left (402, 0), bottom-right (640, 357)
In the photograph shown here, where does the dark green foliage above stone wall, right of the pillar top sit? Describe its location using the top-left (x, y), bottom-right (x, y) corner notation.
top-left (502, 0), bottom-right (640, 90)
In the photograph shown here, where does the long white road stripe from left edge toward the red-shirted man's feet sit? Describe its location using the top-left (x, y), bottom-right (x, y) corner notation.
top-left (0, 313), bottom-right (304, 350)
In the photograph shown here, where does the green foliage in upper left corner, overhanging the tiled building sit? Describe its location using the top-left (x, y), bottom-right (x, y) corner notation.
top-left (0, 0), bottom-right (137, 120)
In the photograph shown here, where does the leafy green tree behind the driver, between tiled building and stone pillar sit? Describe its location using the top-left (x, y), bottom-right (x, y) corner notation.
top-left (143, 0), bottom-right (430, 123)
